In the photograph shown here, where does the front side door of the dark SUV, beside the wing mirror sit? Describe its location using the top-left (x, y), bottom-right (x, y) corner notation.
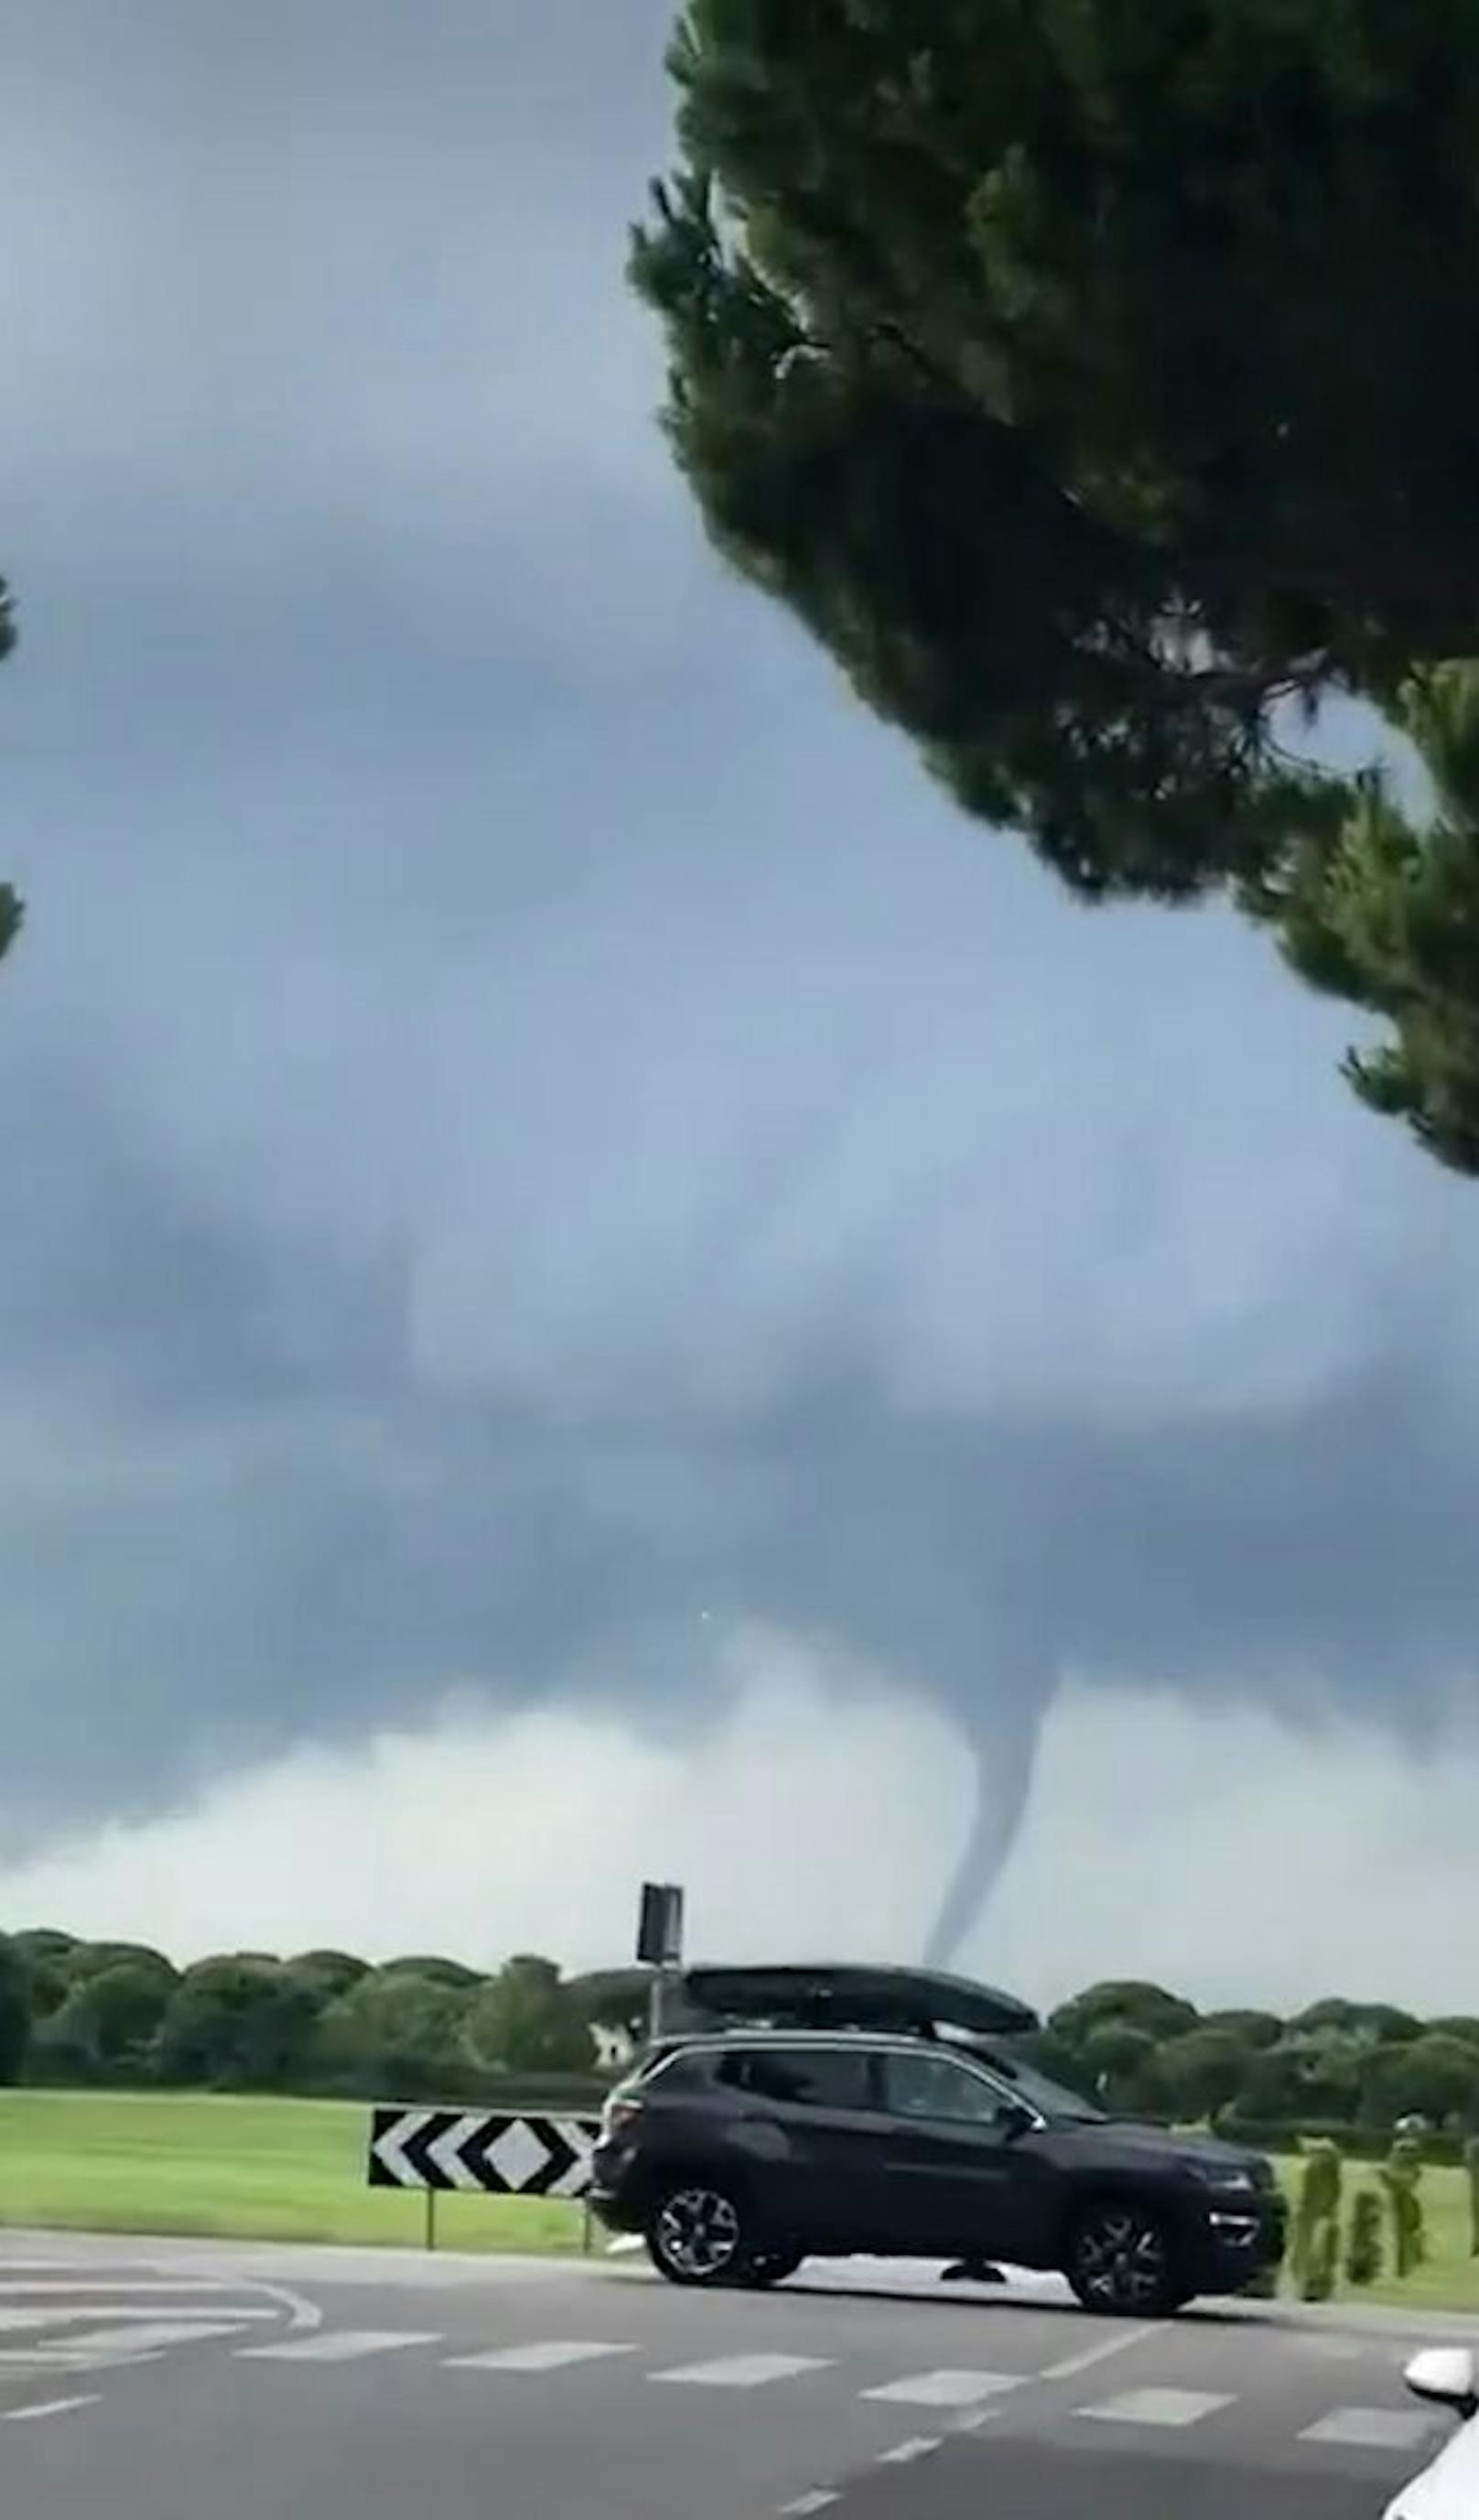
top-left (882, 2046), bottom-right (1045, 2263)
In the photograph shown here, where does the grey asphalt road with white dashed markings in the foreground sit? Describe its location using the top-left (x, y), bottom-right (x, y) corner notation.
top-left (0, 2240), bottom-right (1441, 2520)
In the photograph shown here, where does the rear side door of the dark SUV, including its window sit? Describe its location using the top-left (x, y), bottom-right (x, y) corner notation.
top-left (720, 2041), bottom-right (887, 2248)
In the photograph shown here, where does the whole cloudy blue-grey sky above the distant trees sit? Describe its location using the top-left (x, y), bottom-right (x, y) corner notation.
top-left (0, 0), bottom-right (1479, 1995)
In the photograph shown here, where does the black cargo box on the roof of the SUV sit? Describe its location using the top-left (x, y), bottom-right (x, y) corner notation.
top-left (683, 1961), bottom-right (1038, 2039)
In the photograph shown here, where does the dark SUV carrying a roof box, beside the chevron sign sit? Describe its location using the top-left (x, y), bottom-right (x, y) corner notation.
top-left (592, 1971), bottom-right (1285, 2319)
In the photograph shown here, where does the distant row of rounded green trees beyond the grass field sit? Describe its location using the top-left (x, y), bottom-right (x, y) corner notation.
top-left (0, 1931), bottom-right (1479, 2149)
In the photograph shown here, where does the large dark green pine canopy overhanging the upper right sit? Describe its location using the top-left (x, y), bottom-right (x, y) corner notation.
top-left (632, 0), bottom-right (1479, 1172)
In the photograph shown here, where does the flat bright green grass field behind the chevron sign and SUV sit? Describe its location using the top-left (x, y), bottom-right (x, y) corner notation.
top-left (0, 2092), bottom-right (1479, 2313)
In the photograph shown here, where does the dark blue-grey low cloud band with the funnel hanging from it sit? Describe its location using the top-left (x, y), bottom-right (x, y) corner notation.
top-left (0, 1071), bottom-right (1479, 1910)
